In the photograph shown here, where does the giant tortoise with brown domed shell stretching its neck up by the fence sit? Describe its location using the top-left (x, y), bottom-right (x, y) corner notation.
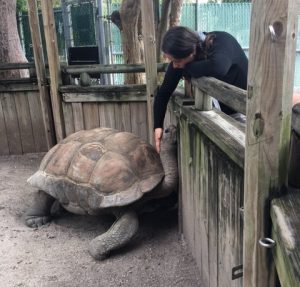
top-left (25, 126), bottom-right (178, 260)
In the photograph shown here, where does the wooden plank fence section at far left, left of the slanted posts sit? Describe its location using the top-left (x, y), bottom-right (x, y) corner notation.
top-left (0, 79), bottom-right (53, 155)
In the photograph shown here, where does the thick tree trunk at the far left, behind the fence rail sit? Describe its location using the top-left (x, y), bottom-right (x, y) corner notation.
top-left (0, 0), bottom-right (28, 79)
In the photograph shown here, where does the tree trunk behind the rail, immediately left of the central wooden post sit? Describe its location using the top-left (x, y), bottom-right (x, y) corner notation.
top-left (120, 0), bottom-right (144, 84)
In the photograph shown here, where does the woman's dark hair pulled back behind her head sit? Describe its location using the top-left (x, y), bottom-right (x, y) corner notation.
top-left (162, 26), bottom-right (215, 59)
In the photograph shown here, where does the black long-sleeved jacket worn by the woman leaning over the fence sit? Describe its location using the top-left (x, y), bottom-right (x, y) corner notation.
top-left (154, 32), bottom-right (248, 128)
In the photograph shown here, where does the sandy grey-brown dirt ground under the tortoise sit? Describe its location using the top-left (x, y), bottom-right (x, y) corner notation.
top-left (0, 154), bottom-right (201, 287)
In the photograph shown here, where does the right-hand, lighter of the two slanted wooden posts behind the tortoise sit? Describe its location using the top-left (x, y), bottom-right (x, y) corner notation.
top-left (41, 0), bottom-right (65, 142)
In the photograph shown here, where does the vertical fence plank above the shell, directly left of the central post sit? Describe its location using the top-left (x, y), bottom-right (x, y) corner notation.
top-left (130, 102), bottom-right (149, 141)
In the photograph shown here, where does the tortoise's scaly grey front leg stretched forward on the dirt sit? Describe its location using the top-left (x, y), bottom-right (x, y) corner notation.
top-left (89, 210), bottom-right (139, 260)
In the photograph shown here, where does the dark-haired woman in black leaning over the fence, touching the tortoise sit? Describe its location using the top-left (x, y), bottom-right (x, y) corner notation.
top-left (154, 26), bottom-right (248, 152)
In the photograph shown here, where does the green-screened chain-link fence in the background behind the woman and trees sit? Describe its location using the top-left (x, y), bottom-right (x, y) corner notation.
top-left (18, 0), bottom-right (300, 86)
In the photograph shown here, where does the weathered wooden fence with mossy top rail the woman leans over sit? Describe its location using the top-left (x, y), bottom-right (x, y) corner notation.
top-left (172, 78), bottom-right (246, 287)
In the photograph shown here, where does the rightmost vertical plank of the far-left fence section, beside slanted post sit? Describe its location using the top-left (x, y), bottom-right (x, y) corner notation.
top-left (28, 92), bottom-right (48, 152)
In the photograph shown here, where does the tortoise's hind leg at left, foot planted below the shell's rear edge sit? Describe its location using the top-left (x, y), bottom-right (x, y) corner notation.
top-left (25, 190), bottom-right (55, 230)
